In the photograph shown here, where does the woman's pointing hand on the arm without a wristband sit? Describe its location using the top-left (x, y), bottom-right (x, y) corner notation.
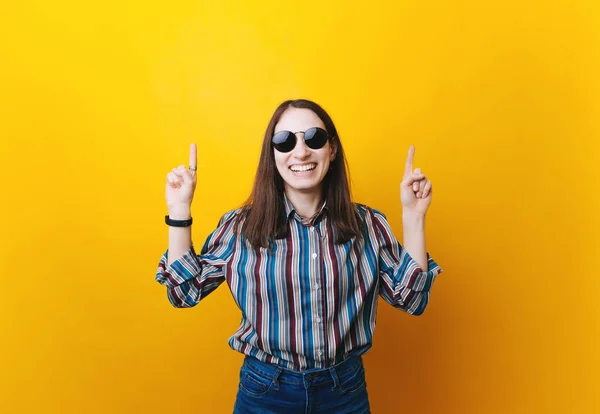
top-left (400, 145), bottom-right (432, 215)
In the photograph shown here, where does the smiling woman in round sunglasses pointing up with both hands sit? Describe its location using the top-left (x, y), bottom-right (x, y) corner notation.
top-left (156, 100), bottom-right (441, 413)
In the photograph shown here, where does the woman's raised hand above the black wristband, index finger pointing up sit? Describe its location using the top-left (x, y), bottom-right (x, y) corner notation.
top-left (166, 143), bottom-right (197, 220)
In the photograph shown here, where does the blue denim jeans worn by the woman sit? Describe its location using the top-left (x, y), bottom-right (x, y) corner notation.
top-left (233, 356), bottom-right (370, 414)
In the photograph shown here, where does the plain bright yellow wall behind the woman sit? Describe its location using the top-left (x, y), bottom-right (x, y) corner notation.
top-left (0, 0), bottom-right (600, 413)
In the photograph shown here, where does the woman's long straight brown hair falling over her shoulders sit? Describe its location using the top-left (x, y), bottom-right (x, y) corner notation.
top-left (236, 99), bottom-right (362, 247)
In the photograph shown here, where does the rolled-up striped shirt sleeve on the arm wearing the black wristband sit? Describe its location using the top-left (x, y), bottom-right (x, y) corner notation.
top-left (155, 212), bottom-right (235, 308)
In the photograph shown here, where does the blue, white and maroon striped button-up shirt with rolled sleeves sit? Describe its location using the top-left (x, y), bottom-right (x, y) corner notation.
top-left (155, 197), bottom-right (442, 371)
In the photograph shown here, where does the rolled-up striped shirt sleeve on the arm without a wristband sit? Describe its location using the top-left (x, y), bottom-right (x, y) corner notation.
top-left (373, 210), bottom-right (442, 315)
